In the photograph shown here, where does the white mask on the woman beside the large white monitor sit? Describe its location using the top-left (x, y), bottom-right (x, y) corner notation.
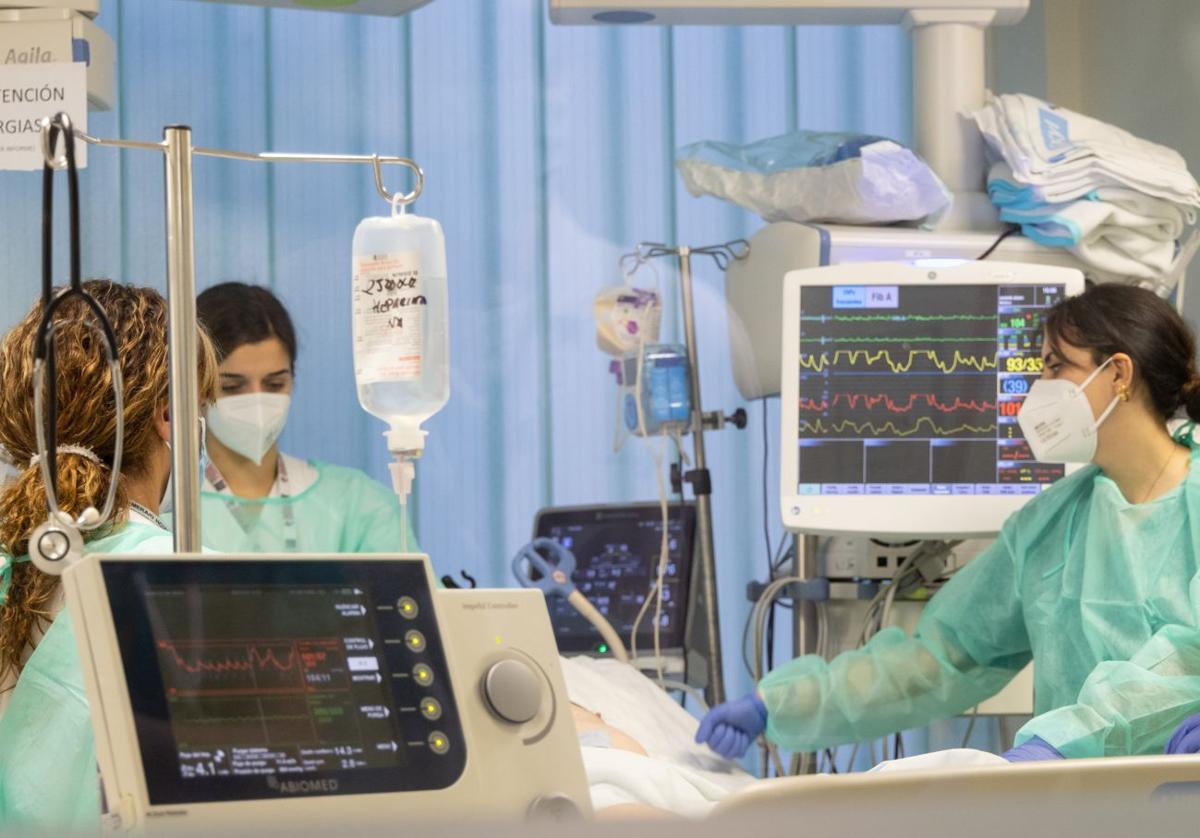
top-left (1016, 358), bottom-right (1121, 462)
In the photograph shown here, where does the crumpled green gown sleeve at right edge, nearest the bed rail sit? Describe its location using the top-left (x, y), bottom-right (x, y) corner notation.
top-left (1016, 574), bottom-right (1200, 758)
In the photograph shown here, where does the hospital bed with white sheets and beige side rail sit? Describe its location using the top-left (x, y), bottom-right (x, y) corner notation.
top-left (563, 659), bottom-right (1200, 821)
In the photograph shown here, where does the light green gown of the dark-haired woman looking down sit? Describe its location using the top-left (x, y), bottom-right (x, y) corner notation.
top-left (200, 461), bottom-right (418, 553)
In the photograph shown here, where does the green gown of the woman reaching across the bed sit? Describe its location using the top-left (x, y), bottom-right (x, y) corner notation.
top-left (758, 447), bottom-right (1200, 758)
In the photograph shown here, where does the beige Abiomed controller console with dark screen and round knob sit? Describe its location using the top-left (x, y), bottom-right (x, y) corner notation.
top-left (64, 555), bottom-right (589, 832)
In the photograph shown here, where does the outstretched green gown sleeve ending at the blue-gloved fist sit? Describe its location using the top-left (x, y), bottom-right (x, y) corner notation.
top-left (758, 516), bottom-right (1032, 752)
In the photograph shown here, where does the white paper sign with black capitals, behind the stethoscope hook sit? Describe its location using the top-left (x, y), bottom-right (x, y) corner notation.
top-left (0, 64), bottom-right (88, 172)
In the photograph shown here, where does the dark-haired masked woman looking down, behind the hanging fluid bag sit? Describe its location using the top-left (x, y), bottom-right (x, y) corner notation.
top-left (196, 282), bottom-right (418, 552)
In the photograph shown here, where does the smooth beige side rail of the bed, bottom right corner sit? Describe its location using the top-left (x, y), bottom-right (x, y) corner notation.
top-left (710, 756), bottom-right (1200, 838)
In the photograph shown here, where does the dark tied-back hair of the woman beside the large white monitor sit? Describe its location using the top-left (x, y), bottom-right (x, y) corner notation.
top-left (1045, 285), bottom-right (1200, 421)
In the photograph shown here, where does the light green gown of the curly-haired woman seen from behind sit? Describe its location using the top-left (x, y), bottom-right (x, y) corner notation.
top-left (0, 521), bottom-right (172, 833)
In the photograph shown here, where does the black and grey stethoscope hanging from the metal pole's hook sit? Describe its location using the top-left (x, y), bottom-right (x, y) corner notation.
top-left (29, 113), bottom-right (125, 576)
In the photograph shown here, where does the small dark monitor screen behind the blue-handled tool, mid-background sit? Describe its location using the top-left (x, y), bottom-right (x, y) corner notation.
top-left (534, 503), bottom-right (695, 654)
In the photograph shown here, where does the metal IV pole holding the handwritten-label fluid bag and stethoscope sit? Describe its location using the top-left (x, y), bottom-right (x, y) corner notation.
top-left (41, 119), bottom-right (425, 553)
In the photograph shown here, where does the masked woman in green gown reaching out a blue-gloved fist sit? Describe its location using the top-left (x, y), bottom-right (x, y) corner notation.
top-left (696, 285), bottom-right (1200, 761)
